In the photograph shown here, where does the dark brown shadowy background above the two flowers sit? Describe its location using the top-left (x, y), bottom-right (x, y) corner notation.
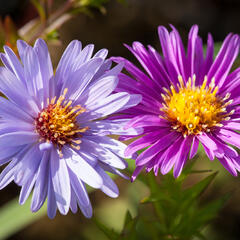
top-left (58, 0), bottom-right (240, 61)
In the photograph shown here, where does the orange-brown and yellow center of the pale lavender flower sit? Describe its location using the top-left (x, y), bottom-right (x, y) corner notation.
top-left (35, 88), bottom-right (88, 152)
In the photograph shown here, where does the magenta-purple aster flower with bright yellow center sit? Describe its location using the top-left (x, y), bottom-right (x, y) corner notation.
top-left (113, 25), bottom-right (240, 180)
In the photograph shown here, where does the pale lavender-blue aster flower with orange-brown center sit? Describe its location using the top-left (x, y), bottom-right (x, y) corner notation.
top-left (0, 39), bottom-right (141, 218)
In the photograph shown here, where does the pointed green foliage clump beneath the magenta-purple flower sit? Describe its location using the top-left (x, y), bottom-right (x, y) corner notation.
top-left (97, 162), bottom-right (229, 240)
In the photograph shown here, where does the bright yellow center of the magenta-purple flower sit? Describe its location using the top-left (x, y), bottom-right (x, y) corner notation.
top-left (160, 75), bottom-right (234, 137)
